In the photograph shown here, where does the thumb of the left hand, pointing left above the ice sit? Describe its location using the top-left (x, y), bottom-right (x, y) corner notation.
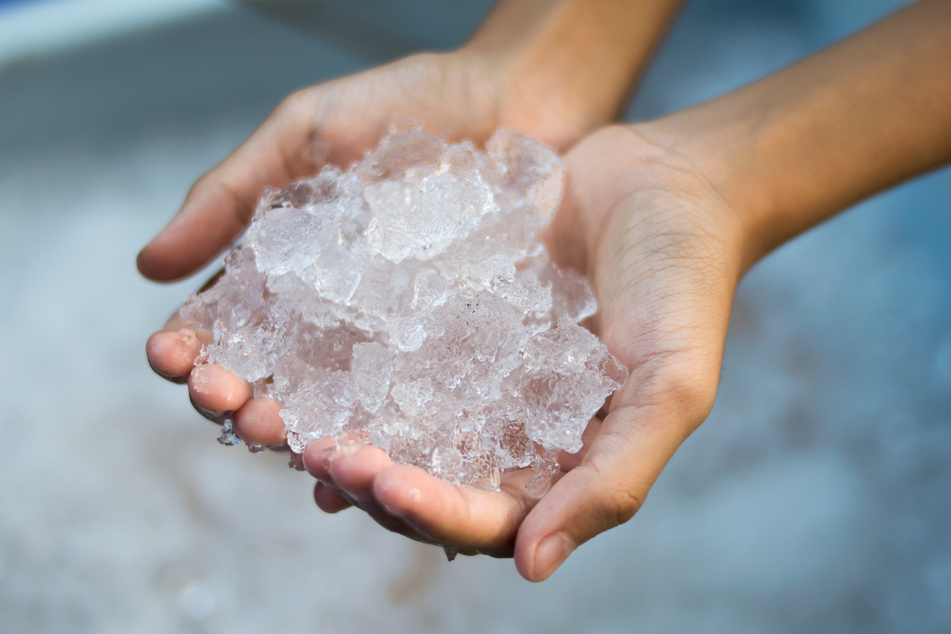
top-left (137, 90), bottom-right (319, 281)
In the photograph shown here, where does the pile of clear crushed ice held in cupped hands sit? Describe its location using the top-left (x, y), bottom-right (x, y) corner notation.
top-left (181, 130), bottom-right (627, 488)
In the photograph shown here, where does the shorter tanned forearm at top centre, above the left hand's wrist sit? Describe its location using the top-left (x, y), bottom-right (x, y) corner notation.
top-left (464, 0), bottom-right (682, 144)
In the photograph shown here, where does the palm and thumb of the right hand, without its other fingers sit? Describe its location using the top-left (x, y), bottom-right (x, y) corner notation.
top-left (516, 128), bottom-right (741, 579)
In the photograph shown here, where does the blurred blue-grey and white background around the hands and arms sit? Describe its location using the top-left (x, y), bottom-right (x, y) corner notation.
top-left (0, 0), bottom-right (951, 634)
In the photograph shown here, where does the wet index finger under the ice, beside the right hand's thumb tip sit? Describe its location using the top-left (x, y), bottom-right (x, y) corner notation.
top-left (373, 465), bottom-right (533, 557)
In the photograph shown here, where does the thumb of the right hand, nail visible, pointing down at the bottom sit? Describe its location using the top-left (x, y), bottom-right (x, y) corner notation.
top-left (515, 398), bottom-right (696, 581)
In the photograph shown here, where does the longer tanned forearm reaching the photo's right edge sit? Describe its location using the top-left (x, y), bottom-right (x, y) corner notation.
top-left (646, 0), bottom-right (951, 268)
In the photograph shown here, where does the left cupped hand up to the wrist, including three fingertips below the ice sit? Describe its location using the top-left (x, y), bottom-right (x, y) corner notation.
top-left (137, 48), bottom-right (590, 454)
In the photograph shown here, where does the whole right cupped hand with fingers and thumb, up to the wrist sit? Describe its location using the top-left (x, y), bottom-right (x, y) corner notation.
top-left (303, 121), bottom-right (743, 580)
